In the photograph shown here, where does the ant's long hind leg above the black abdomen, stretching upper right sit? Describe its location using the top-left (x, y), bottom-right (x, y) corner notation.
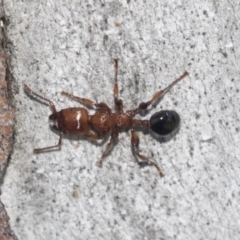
top-left (127, 71), bottom-right (189, 117)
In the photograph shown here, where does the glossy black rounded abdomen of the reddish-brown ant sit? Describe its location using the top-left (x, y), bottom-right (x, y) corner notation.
top-left (150, 110), bottom-right (180, 136)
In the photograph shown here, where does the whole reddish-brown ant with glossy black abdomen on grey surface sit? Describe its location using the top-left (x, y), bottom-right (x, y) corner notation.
top-left (24, 59), bottom-right (188, 177)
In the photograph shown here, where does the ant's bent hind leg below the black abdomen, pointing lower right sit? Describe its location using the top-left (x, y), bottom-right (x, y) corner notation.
top-left (131, 130), bottom-right (164, 177)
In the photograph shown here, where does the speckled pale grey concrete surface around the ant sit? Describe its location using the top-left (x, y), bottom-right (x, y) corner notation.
top-left (2, 0), bottom-right (240, 240)
